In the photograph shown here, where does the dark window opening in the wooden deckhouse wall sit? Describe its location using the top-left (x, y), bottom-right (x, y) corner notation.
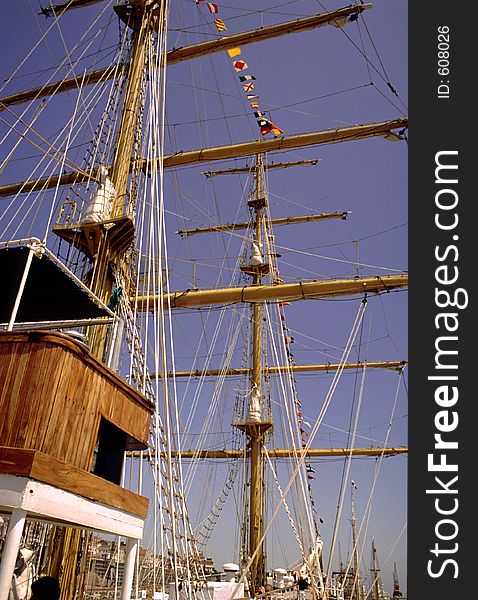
top-left (91, 418), bottom-right (126, 485)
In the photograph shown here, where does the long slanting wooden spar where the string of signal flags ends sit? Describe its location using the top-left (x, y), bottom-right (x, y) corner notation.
top-left (0, 118), bottom-right (408, 197)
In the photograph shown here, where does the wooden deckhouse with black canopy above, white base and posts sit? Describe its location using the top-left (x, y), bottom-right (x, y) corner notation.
top-left (0, 242), bottom-right (154, 600)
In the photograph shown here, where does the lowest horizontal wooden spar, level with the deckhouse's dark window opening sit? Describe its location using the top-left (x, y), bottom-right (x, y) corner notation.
top-left (126, 447), bottom-right (408, 459)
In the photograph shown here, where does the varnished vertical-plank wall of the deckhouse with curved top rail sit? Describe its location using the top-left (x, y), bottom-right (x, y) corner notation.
top-left (0, 331), bottom-right (152, 471)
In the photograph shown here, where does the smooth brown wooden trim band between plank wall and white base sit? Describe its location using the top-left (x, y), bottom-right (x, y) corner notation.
top-left (0, 446), bottom-right (148, 519)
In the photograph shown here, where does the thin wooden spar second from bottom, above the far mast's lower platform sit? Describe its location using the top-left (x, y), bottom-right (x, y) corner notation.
top-left (150, 360), bottom-right (408, 379)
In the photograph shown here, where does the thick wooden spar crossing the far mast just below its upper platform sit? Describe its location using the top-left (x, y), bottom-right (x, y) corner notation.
top-left (132, 275), bottom-right (408, 311)
